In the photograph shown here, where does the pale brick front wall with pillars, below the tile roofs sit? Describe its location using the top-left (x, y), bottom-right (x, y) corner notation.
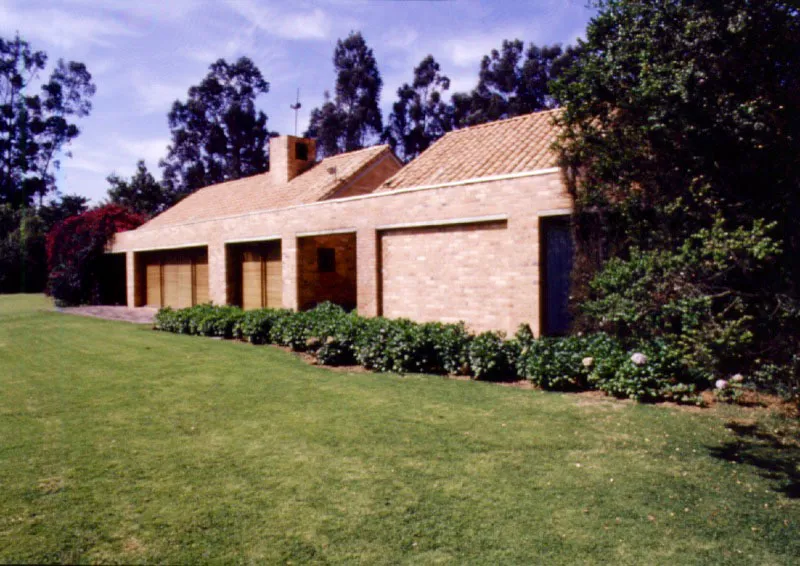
top-left (113, 172), bottom-right (571, 333)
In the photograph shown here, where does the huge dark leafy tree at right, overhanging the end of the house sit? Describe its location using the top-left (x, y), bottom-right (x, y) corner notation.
top-left (555, 0), bottom-right (800, 382)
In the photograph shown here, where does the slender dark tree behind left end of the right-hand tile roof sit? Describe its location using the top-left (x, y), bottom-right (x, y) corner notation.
top-left (383, 55), bottom-right (452, 161)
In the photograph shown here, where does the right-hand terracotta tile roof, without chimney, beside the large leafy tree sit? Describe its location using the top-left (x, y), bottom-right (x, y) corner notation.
top-left (378, 110), bottom-right (559, 191)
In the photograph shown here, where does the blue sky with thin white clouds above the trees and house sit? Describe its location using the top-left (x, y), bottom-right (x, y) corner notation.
top-left (0, 0), bottom-right (592, 202)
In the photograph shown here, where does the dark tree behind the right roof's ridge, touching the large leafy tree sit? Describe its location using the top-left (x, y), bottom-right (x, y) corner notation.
top-left (453, 39), bottom-right (578, 127)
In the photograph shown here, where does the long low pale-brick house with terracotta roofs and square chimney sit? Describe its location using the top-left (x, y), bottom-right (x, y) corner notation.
top-left (110, 111), bottom-right (572, 333)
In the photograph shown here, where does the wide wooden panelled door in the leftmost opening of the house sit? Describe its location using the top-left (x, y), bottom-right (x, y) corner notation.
top-left (144, 250), bottom-right (209, 308)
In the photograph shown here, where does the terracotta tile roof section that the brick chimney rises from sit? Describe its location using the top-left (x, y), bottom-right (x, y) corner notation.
top-left (145, 145), bottom-right (392, 229)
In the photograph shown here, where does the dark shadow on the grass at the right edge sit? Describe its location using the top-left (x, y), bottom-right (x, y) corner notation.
top-left (709, 422), bottom-right (800, 499)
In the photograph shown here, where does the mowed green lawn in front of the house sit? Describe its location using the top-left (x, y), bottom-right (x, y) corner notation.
top-left (0, 296), bottom-right (800, 564)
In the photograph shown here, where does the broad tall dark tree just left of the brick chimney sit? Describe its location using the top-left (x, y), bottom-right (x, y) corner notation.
top-left (160, 57), bottom-right (270, 195)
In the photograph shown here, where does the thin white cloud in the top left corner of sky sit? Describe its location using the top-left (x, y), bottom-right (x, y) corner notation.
top-left (0, 4), bottom-right (136, 49)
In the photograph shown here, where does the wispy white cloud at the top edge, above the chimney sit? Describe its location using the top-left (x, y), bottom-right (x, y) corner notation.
top-left (228, 0), bottom-right (332, 39)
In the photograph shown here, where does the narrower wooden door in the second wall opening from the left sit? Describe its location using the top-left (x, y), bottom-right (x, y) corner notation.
top-left (241, 242), bottom-right (283, 309)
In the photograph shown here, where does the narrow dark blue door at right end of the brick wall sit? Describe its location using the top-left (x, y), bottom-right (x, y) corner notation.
top-left (542, 217), bottom-right (574, 335)
